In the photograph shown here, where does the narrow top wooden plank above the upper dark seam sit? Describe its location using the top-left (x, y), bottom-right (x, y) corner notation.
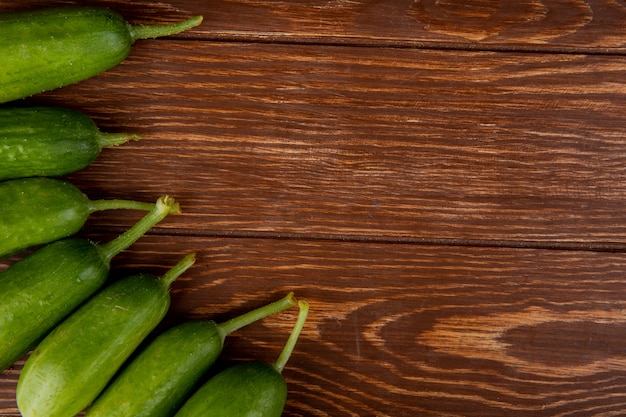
top-left (0, 0), bottom-right (626, 53)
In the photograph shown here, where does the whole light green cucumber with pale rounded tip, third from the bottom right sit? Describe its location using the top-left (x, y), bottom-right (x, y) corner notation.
top-left (17, 250), bottom-right (195, 417)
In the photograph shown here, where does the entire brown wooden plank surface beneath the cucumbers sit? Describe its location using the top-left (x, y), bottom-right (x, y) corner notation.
top-left (0, 0), bottom-right (626, 417)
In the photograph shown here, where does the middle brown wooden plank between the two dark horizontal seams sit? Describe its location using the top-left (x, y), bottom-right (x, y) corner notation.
top-left (18, 41), bottom-right (626, 244)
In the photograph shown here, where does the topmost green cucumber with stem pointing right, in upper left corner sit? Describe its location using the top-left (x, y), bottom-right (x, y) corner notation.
top-left (0, 6), bottom-right (202, 103)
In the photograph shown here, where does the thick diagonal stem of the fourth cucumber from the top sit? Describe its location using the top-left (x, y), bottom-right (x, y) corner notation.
top-left (99, 196), bottom-right (180, 264)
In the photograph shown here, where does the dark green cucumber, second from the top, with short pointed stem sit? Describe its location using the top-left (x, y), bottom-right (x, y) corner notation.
top-left (0, 105), bottom-right (140, 181)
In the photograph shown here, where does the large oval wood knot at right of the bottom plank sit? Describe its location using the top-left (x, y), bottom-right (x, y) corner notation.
top-left (418, 307), bottom-right (626, 377)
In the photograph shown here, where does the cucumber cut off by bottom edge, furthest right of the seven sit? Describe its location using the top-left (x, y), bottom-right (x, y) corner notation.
top-left (175, 300), bottom-right (309, 417)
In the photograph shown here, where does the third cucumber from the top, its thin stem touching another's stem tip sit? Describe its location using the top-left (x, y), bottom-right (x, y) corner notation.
top-left (0, 178), bottom-right (154, 258)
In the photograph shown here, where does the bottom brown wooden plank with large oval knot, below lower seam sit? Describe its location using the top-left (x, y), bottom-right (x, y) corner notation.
top-left (0, 234), bottom-right (626, 417)
